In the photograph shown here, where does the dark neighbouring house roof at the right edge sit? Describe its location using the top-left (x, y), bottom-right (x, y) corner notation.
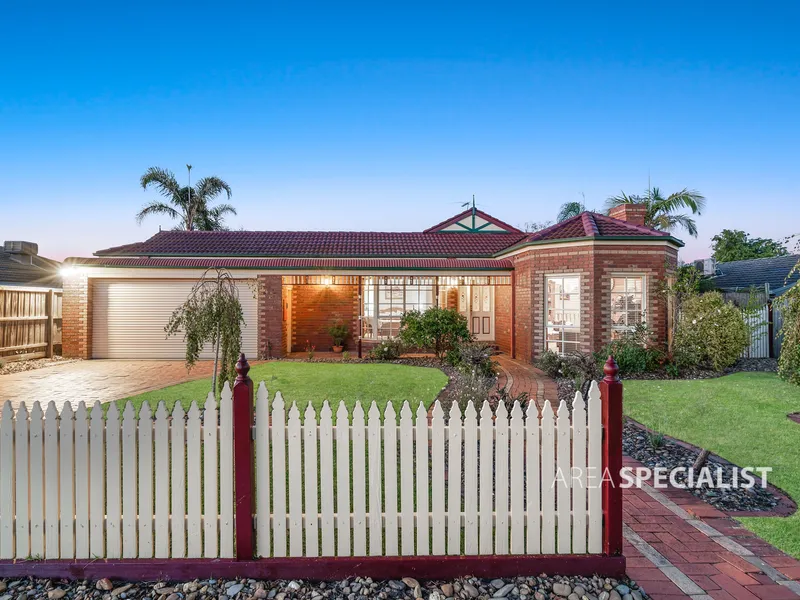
top-left (711, 254), bottom-right (800, 295)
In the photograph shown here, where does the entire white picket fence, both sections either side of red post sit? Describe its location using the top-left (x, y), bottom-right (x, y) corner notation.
top-left (0, 383), bottom-right (602, 559)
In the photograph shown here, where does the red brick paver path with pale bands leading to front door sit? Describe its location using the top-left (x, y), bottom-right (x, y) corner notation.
top-left (497, 356), bottom-right (800, 600)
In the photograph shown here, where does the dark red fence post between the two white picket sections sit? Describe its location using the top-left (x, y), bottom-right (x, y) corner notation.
top-left (233, 354), bottom-right (255, 560)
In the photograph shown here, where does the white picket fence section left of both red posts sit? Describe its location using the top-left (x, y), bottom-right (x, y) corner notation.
top-left (0, 385), bottom-right (234, 559)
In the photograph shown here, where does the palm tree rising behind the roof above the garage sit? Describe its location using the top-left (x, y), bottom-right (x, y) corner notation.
top-left (136, 165), bottom-right (236, 231)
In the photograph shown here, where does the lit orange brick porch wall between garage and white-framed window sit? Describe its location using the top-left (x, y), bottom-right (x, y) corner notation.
top-left (291, 285), bottom-right (359, 352)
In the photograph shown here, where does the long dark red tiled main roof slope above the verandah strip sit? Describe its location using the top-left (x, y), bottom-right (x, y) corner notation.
top-left (95, 231), bottom-right (525, 258)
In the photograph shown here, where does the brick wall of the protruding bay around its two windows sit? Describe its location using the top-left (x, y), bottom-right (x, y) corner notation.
top-left (513, 244), bottom-right (677, 361)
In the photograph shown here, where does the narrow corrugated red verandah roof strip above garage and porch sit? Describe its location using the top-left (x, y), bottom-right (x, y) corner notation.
top-left (65, 256), bottom-right (514, 271)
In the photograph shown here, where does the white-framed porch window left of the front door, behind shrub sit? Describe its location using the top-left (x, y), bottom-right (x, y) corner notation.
top-left (361, 277), bottom-right (434, 340)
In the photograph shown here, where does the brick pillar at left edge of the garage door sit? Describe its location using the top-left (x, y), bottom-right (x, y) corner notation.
top-left (61, 273), bottom-right (92, 358)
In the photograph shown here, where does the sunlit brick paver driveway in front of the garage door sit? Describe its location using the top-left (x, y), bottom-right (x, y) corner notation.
top-left (0, 360), bottom-right (219, 410)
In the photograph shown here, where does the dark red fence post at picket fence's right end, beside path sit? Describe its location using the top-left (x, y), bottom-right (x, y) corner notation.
top-left (600, 356), bottom-right (622, 556)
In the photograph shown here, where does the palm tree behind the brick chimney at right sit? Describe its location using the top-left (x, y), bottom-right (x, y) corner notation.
top-left (606, 187), bottom-right (706, 237)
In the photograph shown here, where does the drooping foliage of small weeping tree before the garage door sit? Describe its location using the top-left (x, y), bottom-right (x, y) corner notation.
top-left (164, 267), bottom-right (244, 392)
